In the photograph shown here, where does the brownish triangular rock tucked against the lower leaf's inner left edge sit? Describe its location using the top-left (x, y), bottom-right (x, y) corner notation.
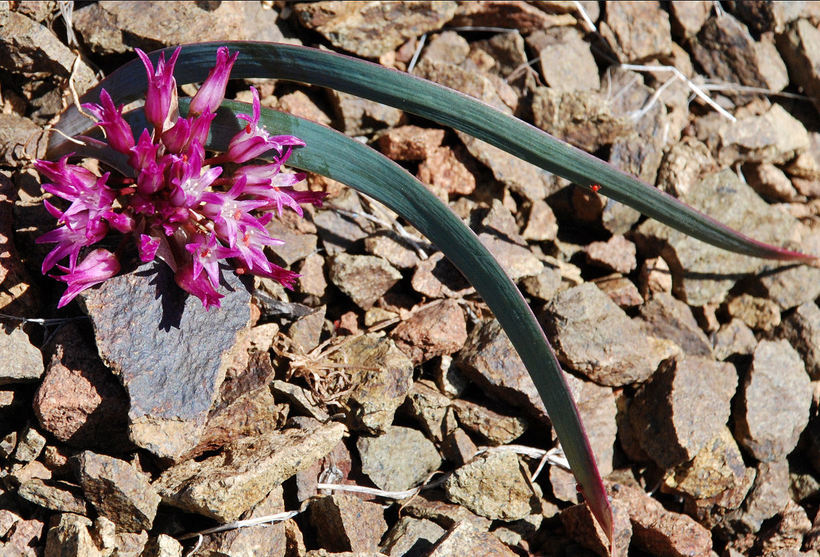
top-left (456, 320), bottom-right (548, 422)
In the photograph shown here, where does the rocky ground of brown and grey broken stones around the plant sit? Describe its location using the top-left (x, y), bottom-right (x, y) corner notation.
top-left (0, 1), bottom-right (820, 557)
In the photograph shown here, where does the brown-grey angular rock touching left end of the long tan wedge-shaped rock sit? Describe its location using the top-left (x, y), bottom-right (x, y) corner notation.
top-left (77, 451), bottom-right (160, 532)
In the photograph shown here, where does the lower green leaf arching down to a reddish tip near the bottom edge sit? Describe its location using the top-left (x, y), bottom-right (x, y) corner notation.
top-left (197, 99), bottom-right (612, 532)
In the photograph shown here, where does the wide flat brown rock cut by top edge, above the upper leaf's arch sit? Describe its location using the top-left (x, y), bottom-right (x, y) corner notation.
top-left (294, 1), bottom-right (456, 58)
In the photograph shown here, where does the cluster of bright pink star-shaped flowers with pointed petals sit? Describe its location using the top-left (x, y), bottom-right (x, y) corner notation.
top-left (35, 47), bottom-right (324, 308)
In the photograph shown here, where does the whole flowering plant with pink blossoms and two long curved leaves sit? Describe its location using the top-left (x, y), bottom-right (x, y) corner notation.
top-left (37, 42), bottom-right (816, 539)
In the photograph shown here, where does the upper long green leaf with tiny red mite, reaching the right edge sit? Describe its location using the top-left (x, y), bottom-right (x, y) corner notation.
top-left (52, 41), bottom-right (816, 260)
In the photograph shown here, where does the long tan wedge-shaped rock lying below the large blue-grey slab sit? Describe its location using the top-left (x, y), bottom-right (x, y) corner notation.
top-left (154, 422), bottom-right (345, 522)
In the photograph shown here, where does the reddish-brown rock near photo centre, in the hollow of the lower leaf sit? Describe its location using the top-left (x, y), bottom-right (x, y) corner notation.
top-left (390, 299), bottom-right (467, 365)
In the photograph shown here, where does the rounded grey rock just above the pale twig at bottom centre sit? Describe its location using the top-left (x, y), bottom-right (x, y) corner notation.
top-left (356, 426), bottom-right (441, 491)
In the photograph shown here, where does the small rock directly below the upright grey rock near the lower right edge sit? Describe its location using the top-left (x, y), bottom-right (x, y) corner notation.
top-left (738, 460), bottom-right (790, 532)
